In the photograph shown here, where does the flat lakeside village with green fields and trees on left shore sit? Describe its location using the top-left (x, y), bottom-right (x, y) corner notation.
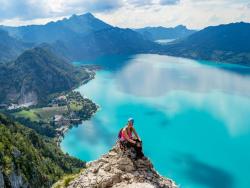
top-left (0, 91), bottom-right (98, 146)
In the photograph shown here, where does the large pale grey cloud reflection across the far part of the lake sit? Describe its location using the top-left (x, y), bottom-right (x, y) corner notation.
top-left (116, 55), bottom-right (250, 97)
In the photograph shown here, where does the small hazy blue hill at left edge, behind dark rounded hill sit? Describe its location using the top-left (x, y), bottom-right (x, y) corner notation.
top-left (0, 29), bottom-right (32, 63)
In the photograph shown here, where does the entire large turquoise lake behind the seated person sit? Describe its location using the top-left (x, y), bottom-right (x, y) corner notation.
top-left (61, 54), bottom-right (250, 188)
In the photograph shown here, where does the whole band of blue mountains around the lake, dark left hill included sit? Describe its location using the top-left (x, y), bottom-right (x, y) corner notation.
top-left (0, 13), bottom-right (250, 107)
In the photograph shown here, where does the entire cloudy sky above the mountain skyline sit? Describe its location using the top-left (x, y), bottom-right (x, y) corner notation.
top-left (0, 0), bottom-right (250, 29)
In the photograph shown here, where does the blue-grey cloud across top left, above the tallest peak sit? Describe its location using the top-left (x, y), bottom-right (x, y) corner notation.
top-left (0, 0), bottom-right (123, 20)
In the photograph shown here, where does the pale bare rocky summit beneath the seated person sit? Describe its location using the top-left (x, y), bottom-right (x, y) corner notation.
top-left (68, 144), bottom-right (177, 188)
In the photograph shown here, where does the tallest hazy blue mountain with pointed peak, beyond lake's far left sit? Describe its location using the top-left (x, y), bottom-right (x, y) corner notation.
top-left (0, 13), bottom-right (157, 61)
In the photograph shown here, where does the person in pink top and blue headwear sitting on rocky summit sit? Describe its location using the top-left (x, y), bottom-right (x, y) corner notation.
top-left (118, 118), bottom-right (144, 158)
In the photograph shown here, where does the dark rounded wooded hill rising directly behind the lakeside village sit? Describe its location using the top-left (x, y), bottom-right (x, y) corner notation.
top-left (0, 48), bottom-right (88, 104)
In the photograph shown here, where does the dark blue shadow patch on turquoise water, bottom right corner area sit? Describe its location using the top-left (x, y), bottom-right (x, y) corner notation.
top-left (174, 154), bottom-right (235, 188)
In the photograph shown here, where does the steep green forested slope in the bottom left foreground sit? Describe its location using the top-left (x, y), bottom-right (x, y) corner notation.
top-left (0, 113), bottom-right (85, 187)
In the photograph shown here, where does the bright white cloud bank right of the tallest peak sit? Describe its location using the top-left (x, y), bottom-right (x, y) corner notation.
top-left (98, 0), bottom-right (250, 29)
